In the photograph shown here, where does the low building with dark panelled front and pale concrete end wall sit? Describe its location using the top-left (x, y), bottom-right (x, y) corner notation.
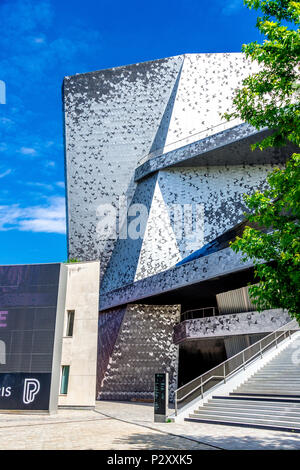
top-left (0, 261), bottom-right (99, 412)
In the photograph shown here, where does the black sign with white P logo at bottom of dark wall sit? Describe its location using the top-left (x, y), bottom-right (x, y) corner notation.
top-left (0, 373), bottom-right (51, 410)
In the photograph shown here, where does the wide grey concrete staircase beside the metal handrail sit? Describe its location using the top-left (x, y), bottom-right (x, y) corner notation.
top-left (185, 340), bottom-right (300, 432)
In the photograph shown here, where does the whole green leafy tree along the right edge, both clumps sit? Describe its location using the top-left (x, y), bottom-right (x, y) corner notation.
top-left (225, 0), bottom-right (300, 323)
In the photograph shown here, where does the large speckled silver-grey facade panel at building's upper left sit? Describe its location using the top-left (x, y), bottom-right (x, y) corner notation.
top-left (63, 56), bottom-right (184, 279)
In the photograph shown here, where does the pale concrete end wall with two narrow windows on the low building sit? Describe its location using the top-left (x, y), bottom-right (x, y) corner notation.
top-left (58, 261), bottom-right (99, 407)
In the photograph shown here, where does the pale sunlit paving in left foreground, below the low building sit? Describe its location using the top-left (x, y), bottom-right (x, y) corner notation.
top-left (0, 410), bottom-right (211, 450)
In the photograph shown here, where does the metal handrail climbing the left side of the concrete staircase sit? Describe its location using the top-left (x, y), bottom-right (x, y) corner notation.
top-left (175, 320), bottom-right (299, 416)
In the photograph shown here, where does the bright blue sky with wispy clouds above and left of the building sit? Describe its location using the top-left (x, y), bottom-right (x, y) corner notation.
top-left (0, 0), bottom-right (261, 264)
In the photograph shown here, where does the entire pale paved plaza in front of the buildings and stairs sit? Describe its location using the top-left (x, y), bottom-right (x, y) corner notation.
top-left (0, 401), bottom-right (300, 450)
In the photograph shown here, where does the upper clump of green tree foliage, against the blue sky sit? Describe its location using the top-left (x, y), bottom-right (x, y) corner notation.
top-left (225, 0), bottom-right (300, 150)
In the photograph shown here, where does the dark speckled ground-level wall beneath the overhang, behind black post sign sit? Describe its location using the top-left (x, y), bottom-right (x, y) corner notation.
top-left (97, 304), bottom-right (180, 400)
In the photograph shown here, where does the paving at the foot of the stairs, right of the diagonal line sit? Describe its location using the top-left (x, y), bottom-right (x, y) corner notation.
top-left (96, 401), bottom-right (300, 450)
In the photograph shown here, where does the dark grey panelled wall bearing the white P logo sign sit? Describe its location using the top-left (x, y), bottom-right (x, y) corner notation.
top-left (0, 264), bottom-right (60, 410)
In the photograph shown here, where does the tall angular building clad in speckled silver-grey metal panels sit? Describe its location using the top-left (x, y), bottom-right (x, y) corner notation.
top-left (63, 53), bottom-right (293, 400)
